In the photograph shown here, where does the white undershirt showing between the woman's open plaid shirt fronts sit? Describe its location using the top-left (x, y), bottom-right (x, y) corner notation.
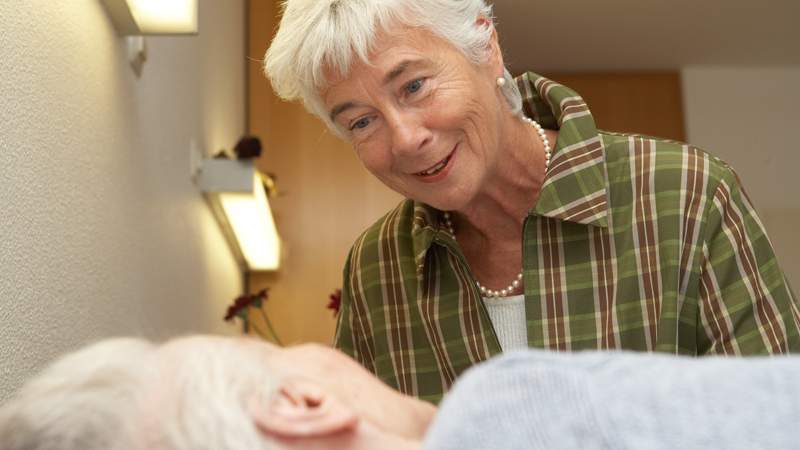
top-left (483, 295), bottom-right (528, 352)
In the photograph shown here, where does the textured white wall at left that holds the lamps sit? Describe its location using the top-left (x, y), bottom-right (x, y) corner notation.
top-left (0, 0), bottom-right (245, 401)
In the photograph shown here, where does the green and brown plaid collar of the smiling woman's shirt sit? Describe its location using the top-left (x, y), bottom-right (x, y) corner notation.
top-left (412, 72), bottom-right (608, 267)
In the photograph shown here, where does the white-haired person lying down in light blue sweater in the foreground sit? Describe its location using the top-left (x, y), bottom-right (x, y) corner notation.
top-left (0, 336), bottom-right (800, 450)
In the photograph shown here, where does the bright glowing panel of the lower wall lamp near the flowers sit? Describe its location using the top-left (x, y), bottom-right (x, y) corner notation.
top-left (219, 175), bottom-right (280, 270)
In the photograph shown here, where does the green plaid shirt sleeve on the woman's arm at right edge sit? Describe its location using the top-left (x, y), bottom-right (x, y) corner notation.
top-left (697, 166), bottom-right (800, 355)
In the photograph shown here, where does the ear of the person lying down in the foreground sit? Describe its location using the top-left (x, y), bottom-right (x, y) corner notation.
top-left (250, 380), bottom-right (358, 438)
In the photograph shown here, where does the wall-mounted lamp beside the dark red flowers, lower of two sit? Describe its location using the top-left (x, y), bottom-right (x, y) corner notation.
top-left (197, 159), bottom-right (281, 271)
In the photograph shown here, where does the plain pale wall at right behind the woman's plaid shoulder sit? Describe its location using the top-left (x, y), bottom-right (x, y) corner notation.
top-left (682, 66), bottom-right (800, 288)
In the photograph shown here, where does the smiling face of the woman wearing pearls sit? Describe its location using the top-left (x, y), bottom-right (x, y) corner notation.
top-left (322, 22), bottom-right (509, 210)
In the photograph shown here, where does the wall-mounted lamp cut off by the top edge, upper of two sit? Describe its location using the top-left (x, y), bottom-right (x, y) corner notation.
top-left (102, 0), bottom-right (197, 36)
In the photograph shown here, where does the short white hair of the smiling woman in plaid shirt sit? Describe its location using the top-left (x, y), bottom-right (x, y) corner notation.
top-left (264, 0), bottom-right (522, 136)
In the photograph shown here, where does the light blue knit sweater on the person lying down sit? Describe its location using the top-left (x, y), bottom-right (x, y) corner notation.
top-left (423, 350), bottom-right (800, 450)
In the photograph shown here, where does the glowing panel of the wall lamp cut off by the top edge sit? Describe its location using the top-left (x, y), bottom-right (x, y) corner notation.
top-left (128, 0), bottom-right (197, 34)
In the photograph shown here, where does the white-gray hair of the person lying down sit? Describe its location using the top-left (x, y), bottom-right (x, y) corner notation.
top-left (0, 339), bottom-right (277, 450)
